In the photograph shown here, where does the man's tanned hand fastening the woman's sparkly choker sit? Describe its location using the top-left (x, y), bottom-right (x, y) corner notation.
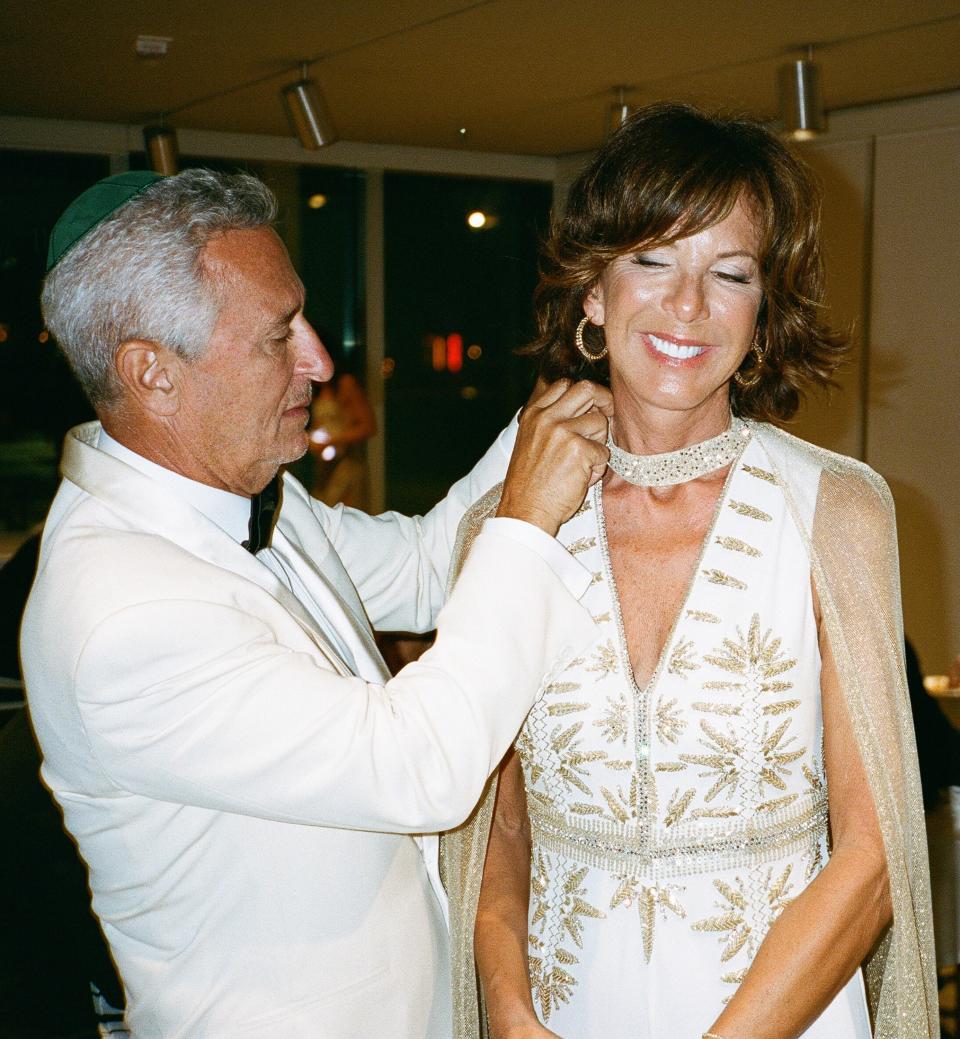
top-left (497, 379), bottom-right (613, 537)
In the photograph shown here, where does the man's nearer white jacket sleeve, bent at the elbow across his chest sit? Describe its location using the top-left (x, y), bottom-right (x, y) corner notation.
top-left (76, 532), bottom-right (593, 832)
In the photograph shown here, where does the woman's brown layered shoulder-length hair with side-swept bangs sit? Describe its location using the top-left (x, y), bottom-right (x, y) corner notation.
top-left (523, 103), bottom-right (847, 421)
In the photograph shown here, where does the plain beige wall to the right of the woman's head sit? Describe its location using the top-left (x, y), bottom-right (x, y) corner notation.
top-left (798, 92), bottom-right (960, 672)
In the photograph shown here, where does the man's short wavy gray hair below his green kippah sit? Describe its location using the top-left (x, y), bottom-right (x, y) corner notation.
top-left (42, 169), bottom-right (276, 408)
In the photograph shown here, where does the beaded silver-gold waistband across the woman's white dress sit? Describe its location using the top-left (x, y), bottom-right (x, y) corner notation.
top-left (528, 794), bottom-right (828, 877)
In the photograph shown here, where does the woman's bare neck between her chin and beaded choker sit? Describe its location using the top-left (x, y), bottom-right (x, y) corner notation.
top-left (612, 394), bottom-right (730, 455)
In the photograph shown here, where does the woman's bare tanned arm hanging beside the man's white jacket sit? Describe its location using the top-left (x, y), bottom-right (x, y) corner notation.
top-left (474, 748), bottom-right (555, 1039)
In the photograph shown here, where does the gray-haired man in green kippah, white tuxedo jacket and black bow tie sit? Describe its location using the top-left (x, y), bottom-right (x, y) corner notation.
top-left (22, 170), bottom-right (609, 1039)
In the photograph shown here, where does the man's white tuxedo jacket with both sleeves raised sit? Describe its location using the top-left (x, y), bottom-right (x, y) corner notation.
top-left (22, 423), bottom-right (593, 1039)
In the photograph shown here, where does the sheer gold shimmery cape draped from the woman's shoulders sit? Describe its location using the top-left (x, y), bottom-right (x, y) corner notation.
top-left (441, 422), bottom-right (940, 1039)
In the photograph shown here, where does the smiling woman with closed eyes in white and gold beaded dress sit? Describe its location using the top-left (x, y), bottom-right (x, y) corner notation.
top-left (445, 105), bottom-right (938, 1039)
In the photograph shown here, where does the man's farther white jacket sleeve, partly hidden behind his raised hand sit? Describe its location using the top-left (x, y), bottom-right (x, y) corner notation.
top-left (312, 418), bottom-right (517, 632)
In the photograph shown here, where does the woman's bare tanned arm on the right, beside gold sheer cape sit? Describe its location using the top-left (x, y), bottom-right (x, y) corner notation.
top-left (710, 592), bottom-right (891, 1039)
